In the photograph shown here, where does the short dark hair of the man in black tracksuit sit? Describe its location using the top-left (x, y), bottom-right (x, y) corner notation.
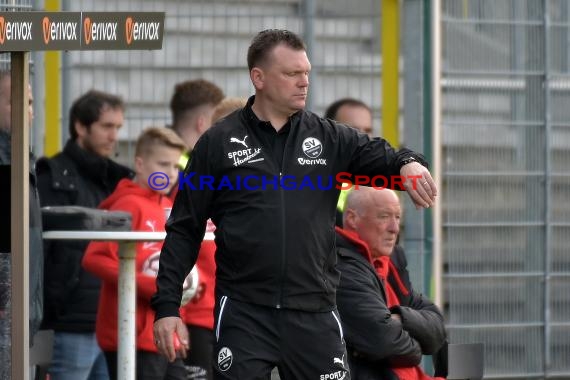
top-left (247, 29), bottom-right (307, 71)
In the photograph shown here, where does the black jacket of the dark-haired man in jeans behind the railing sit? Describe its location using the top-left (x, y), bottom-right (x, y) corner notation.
top-left (37, 140), bottom-right (133, 332)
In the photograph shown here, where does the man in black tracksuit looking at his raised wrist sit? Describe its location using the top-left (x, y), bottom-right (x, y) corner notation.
top-left (152, 30), bottom-right (435, 380)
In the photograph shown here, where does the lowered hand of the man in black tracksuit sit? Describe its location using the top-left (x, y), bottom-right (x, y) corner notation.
top-left (154, 317), bottom-right (190, 362)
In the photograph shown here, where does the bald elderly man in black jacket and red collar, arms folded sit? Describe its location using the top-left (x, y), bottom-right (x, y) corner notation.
top-left (337, 187), bottom-right (446, 380)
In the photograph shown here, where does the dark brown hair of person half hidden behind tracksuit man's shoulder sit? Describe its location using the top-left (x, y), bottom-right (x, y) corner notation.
top-left (170, 79), bottom-right (225, 128)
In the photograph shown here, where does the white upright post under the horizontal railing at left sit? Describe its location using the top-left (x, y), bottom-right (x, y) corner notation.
top-left (117, 242), bottom-right (136, 380)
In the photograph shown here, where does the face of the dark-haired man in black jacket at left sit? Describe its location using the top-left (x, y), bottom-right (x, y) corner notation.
top-left (75, 106), bottom-right (124, 158)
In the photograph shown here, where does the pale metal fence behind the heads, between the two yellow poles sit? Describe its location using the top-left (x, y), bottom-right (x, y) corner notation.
top-left (53, 0), bottom-right (381, 165)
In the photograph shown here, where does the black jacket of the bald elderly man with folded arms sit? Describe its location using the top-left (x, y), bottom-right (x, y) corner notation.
top-left (336, 232), bottom-right (446, 380)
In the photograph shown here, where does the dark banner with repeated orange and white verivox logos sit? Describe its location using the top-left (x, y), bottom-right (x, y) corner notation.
top-left (0, 12), bottom-right (164, 51)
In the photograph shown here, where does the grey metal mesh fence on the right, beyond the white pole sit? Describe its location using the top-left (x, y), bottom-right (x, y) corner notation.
top-left (441, 0), bottom-right (570, 379)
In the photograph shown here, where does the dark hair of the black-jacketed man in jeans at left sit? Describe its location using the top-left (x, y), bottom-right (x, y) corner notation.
top-left (69, 90), bottom-right (125, 140)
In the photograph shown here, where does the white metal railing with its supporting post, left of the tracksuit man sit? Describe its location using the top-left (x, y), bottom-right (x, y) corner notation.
top-left (43, 231), bottom-right (214, 380)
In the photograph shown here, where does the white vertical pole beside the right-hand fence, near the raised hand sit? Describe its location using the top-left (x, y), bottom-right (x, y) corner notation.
top-left (431, 0), bottom-right (443, 308)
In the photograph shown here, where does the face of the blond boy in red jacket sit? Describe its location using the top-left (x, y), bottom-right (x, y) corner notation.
top-left (135, 145), bottom-right (182, 194)
